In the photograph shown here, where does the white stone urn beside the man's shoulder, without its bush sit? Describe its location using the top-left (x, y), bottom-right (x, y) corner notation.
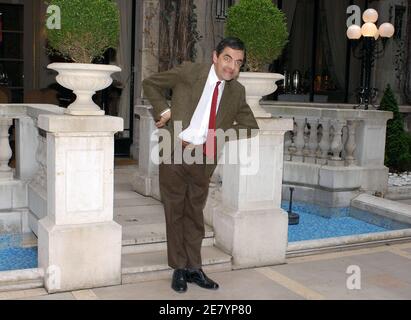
top-left (238, 72), bottom-right (284, 118)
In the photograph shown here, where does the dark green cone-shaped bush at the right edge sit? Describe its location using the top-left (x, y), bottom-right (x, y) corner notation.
top-left (379, 85), bottom-right (411, 172)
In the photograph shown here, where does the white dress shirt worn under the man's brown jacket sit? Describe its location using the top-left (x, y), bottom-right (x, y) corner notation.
top-left (178, 65), bottom-right (225, 144)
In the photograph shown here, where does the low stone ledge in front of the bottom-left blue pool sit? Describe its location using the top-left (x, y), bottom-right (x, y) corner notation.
top-left (0, 268), bottom-right (44, 292)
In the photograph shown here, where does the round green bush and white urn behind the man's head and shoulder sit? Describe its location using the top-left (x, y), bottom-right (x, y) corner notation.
top-left (225, 0), bottom-right (288, 117)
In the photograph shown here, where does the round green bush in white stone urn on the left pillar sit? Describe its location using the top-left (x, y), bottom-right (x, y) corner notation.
top-left (46, 0), bottom-right (121, 115)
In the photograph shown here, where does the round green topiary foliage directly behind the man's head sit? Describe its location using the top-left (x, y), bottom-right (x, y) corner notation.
top-left (225, 0), bottom-right (288, 71)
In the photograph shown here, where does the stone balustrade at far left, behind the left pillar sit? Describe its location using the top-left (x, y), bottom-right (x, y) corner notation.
top-left (0, 104), bottom-right (64, 212)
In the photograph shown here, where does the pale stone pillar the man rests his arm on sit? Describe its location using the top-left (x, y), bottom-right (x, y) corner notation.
top-left (213, 118), bottom-right (293, 268)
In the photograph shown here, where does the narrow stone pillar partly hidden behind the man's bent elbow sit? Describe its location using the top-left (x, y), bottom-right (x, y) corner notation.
top-left (133, 105), bottom-right (160, 200)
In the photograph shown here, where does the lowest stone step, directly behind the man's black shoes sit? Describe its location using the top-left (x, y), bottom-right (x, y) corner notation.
top-left (122, 247), bottom-right (232, 284)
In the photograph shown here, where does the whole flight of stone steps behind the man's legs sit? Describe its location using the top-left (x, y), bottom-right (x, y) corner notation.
top-left (114, 166), bottom-right (231, 283)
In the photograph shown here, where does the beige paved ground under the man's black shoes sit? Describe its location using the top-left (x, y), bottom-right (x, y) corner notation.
top-left (0, 242), bottom-right (411, 300)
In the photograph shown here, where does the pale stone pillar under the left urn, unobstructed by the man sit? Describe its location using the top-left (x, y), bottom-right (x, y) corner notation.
top-left (38, 115), bottom-right (123, 292)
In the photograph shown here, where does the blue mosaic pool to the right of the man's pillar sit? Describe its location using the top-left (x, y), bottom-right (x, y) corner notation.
top-left (281, 201), bottom-right (410, 242)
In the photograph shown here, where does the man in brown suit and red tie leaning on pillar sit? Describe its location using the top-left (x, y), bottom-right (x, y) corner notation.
top-left (143, 38), bottom-right (258, 292)
